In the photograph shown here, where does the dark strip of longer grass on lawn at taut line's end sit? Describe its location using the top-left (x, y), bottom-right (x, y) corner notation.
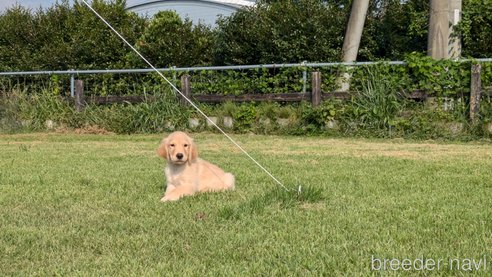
top-left (219, 183), bottom-right (323, 220)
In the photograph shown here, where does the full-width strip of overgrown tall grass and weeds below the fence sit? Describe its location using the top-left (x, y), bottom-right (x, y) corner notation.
top-left (0, 87), bottom-right (492, 140)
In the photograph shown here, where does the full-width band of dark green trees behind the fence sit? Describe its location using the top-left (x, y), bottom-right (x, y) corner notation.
top-left (0, 0), bottom-right (492, 71)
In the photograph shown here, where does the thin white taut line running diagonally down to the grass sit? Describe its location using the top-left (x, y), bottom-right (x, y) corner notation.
top-left (82, 0), bottom-right (289, 191)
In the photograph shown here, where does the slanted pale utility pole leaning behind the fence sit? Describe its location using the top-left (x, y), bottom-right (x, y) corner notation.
top-left (339, 0), bottom-right (369, 91)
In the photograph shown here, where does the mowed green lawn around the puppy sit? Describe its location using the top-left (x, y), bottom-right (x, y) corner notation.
top-left (0, 133), bottom-right (492, 276)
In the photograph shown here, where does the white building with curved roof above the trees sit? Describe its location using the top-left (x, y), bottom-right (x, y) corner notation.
top-left (127, 0), bottom-right (255, 26)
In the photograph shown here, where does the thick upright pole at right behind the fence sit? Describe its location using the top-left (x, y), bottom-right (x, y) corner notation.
top-left (427, 0), bottom-right (461, 60)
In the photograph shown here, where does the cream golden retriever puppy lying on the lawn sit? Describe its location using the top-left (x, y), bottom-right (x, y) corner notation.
top-left (157, 131), bottom-right (234, 201)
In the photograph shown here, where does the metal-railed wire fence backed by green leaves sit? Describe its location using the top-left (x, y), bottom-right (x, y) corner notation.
top-left (0, 58), bottom-right (492, 97)
